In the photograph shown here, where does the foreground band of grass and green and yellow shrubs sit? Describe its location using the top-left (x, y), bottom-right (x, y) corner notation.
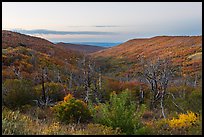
top-left (2, 85), bottom-right (202, 135)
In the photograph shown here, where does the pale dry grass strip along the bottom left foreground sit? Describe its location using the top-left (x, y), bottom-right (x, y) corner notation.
top-left (2, 108), bottom-right (120, 135)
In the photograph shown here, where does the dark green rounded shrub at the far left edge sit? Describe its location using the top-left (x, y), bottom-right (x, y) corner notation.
top-left (3, 79), bottom-right (36, 108)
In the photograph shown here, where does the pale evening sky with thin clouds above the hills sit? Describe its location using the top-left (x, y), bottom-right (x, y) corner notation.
top-left (2, 2), bottom-right (202, 42)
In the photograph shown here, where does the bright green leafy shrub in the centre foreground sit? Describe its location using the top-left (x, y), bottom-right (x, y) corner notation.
top-left (92, 90), bottom-right (144, 134)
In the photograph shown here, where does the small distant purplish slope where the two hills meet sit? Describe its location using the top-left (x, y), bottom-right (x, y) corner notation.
top-left (57, 42), bottom-right (106, 53)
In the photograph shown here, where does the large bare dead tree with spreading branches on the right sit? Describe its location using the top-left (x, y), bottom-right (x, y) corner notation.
top-left (139, 59), bottom-right (176, 118)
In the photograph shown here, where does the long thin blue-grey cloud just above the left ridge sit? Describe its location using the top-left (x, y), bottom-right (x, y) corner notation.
top-left (12, 29), bottom-right (117, 35)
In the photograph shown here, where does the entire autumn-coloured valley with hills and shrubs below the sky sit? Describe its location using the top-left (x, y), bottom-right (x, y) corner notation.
top-left (2, 30), bottom-right (202, 135)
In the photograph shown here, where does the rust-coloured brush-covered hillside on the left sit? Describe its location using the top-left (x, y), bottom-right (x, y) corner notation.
top-left (2, 30), bottom-right (82, 79)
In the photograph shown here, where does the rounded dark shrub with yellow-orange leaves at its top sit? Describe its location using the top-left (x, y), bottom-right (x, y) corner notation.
top-left (53, 94), bottom-right (91, 123)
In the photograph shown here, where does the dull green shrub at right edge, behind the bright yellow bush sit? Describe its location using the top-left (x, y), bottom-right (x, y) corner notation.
top-left (164, 86), bottom-right (202, 114)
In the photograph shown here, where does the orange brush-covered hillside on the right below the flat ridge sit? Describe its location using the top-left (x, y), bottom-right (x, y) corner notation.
top-left (91, 36), bottom-right (202, 74)
